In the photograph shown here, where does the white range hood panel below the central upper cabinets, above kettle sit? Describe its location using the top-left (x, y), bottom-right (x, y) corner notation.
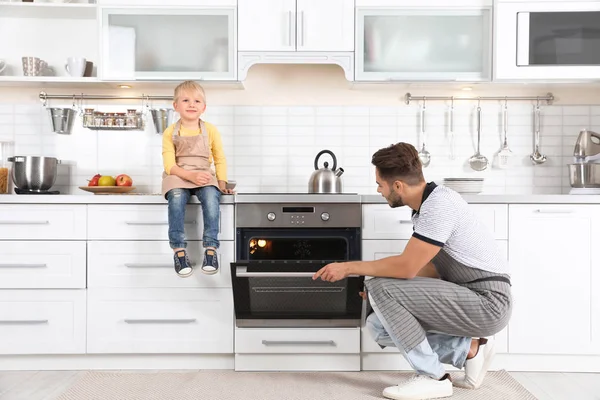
top-left (237, 51), bottom-right (354, 82)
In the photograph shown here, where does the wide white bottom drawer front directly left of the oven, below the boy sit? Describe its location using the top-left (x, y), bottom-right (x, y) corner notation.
top-left (87, 288), bottom-right (234, 354)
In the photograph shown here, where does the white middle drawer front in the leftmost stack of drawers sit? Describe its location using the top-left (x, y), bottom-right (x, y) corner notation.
top-left (0, 241), bottom-right (86, 289)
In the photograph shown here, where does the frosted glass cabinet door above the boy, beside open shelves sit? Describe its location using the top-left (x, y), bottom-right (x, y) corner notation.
top-left (101, 7), bottom-right (237, 80)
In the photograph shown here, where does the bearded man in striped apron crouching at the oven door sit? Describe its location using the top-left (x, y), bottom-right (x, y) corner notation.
top-left (313, 143), bottom-right (512, 400)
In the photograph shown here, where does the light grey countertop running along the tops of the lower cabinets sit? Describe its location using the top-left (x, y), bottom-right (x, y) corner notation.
top-left (0, 194), bottom-right (600, 204)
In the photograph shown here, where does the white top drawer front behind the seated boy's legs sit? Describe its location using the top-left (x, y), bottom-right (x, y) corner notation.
top-left (88, 204), bottom-right (234, 240)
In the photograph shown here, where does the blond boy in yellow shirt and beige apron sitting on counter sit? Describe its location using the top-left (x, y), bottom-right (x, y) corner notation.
top-left (162, 81), bottom-right (233, 277)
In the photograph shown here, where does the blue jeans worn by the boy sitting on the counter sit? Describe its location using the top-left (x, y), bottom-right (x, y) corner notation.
top-left (167, 186), bottom-right (221, 249)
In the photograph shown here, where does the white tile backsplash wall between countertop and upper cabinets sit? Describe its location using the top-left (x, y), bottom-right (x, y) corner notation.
top-left (0, 102), bottom-right (600, 194)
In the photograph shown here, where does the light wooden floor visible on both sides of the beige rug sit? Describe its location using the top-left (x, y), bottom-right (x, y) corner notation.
top-left (0, 371), bottom-right (600, 400)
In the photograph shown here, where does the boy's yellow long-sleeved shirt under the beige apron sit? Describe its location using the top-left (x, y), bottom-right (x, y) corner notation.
top-left (163, 121), bottom-right (227, 182)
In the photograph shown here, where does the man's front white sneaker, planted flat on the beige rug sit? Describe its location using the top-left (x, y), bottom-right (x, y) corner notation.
top-left (383, 374), bottom-right (452, 400)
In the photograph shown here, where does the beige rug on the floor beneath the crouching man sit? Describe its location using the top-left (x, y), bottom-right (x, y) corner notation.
top-left (56, 370), bottom-right (536, 400)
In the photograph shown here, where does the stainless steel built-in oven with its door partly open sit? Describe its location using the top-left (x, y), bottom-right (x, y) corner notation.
top-left (231, 203), bottom-right (364, 328)
